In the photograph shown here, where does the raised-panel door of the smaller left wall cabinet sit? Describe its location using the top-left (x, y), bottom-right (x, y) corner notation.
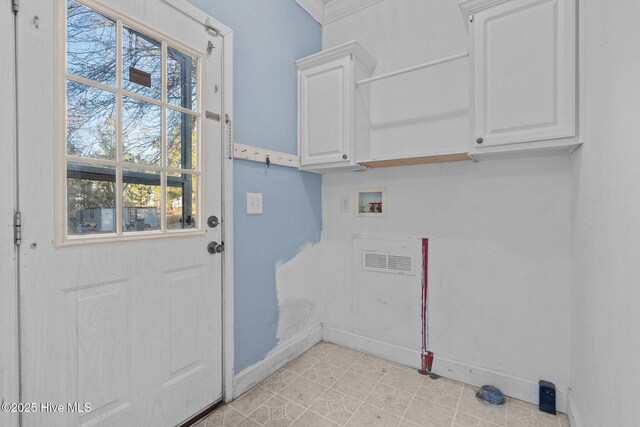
top-left (299, 56), bottom-right (353, 166)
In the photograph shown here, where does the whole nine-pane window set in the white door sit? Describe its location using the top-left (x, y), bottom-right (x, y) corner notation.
top-left (64, 0), bottom-right (202, 239)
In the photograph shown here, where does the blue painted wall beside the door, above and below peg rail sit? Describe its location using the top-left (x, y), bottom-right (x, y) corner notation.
top-left (190, 0), bottom-right (322, 372)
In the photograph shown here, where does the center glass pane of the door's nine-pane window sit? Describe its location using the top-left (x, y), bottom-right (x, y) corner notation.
top-left (122, 96), bottom-right (162, 165)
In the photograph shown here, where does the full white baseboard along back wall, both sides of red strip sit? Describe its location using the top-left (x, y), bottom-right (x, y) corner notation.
top-left (322, 327), bottom-right (568, 414)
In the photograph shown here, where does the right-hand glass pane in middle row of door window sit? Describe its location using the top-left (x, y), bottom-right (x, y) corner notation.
top-left (167, 109), bottom-right (198, 169)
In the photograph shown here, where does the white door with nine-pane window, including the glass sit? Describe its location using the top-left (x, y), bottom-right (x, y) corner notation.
top-left (18, 0), bottom-right (223, 427)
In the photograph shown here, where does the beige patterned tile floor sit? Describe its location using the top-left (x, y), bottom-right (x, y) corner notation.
top-left (196, 342), bottom-right (569, 427)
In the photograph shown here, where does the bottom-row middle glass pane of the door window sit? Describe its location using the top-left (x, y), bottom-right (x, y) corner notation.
top-left (122, 169), bottom-right (162, 232)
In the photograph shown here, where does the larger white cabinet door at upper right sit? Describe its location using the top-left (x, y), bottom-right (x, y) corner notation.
top-left (471, 0), bottom-right (576, 149)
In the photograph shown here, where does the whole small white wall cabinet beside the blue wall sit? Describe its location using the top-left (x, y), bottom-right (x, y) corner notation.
top-left (296, 41), bottom-right (376, 172)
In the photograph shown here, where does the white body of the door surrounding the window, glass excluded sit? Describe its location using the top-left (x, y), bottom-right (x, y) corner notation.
top-left (18, 0), bottom-right (222, 426)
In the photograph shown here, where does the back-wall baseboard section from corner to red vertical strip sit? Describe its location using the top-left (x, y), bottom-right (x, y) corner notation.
top-left (322, 326), bottom-right (420, 369)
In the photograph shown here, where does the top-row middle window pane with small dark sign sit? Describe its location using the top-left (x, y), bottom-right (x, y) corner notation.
top-left (122, 27), bottom-right (162, 99)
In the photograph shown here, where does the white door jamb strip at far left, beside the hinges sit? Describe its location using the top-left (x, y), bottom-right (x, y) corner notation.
top-left (0, 0), bottom-right (18, 427)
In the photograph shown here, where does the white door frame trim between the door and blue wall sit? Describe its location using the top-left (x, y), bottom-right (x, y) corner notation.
top-left (164, 0), bottom-right (236, 402)
